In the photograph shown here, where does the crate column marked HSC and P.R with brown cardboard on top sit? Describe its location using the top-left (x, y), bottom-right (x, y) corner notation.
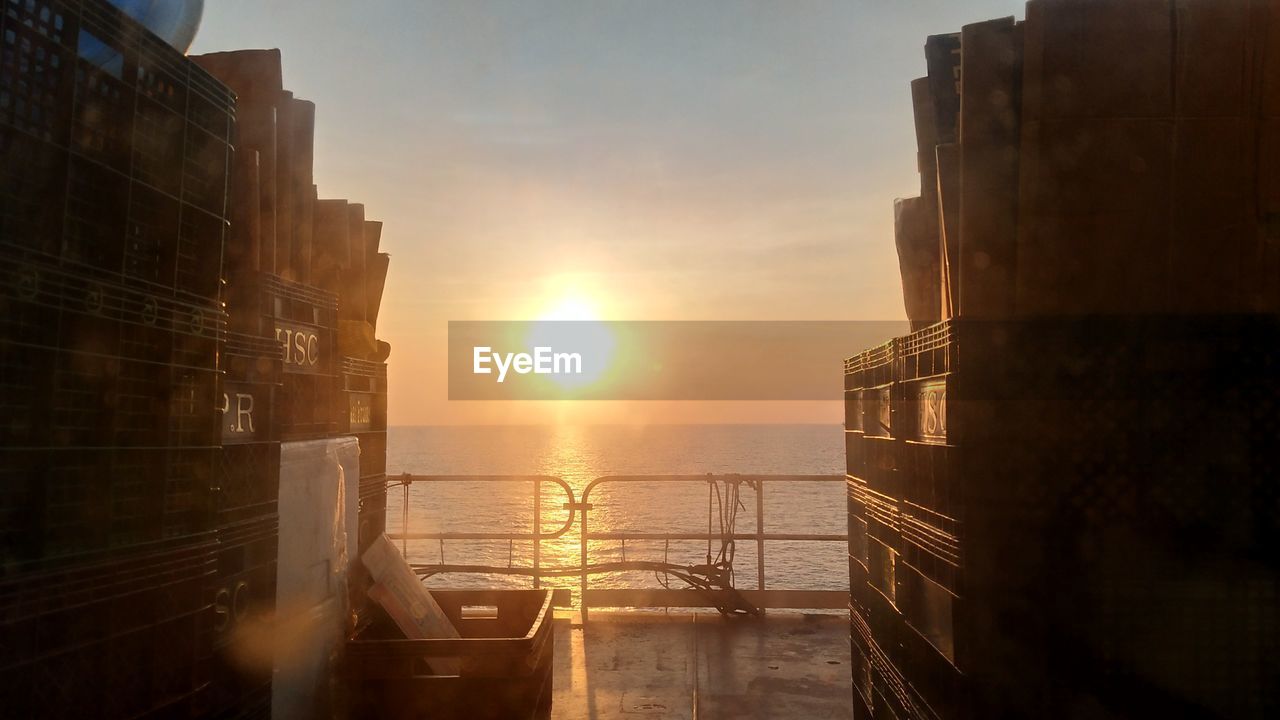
top-left (193, 51), bottom-right (327, 717)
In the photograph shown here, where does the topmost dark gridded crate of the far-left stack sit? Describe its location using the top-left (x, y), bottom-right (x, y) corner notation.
top-left (0, 0), bottom-right (227, 297)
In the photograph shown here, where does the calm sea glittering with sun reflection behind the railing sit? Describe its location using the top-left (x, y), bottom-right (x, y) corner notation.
top-left (387, 425), bottom-right (849, 602)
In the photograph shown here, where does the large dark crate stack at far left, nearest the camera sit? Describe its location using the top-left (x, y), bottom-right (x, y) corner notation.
top-left (0, 0), bottom-right (234, 717)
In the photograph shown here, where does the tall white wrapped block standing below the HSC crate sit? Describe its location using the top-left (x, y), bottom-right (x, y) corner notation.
top-left (271, 437), bottom-right (360, 720)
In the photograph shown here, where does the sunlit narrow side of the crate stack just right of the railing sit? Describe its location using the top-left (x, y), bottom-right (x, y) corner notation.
top-left (845, 323), bottom-right (964, 717)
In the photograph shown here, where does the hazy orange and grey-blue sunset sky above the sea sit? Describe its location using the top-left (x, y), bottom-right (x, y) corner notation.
top-left (192, 0), bottom-right (1024, 425)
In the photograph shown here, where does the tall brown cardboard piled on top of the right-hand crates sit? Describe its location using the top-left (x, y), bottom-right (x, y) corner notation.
top-left (895, 0), bottom-right (1280, 331)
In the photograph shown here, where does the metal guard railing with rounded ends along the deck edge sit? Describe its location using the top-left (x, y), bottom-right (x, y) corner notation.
top-left (388, 473), bottom-right (849, 620)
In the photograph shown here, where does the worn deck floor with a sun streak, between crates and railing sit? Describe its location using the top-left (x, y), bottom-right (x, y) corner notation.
top-left (552, 611), bottom-right (852, 720)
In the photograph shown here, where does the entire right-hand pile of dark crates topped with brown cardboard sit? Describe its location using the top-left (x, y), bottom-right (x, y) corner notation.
top-left (846, 0), bottom-right (1280, 717)
